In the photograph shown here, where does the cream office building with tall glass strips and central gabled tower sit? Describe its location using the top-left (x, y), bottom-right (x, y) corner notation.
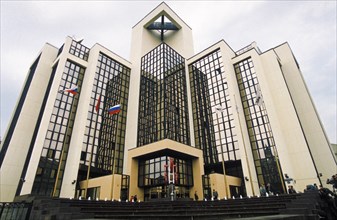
top-left (0, 3), bottom-right (336, 201)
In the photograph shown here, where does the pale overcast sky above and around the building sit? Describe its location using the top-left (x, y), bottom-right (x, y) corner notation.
top-left (1, 0), bottom-right (337, 143)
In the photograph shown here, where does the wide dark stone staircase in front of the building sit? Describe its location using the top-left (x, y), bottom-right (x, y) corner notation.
top-left (1, 191), bottom-right (327, 220)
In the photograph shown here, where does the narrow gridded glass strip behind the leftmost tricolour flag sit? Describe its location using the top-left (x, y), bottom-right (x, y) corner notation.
top-left (32, 60), bottom-right (85, 197)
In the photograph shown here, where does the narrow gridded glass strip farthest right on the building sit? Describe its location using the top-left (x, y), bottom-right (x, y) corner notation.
top-left (234, 58), bottom-right (285, 193)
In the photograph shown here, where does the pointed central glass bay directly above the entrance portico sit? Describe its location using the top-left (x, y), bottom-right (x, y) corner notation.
top-left (137, 43), bottom-right (190, 146)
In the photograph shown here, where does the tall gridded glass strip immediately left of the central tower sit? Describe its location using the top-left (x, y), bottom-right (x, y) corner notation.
top-left (78, 53), bottom-right (130, 185)
